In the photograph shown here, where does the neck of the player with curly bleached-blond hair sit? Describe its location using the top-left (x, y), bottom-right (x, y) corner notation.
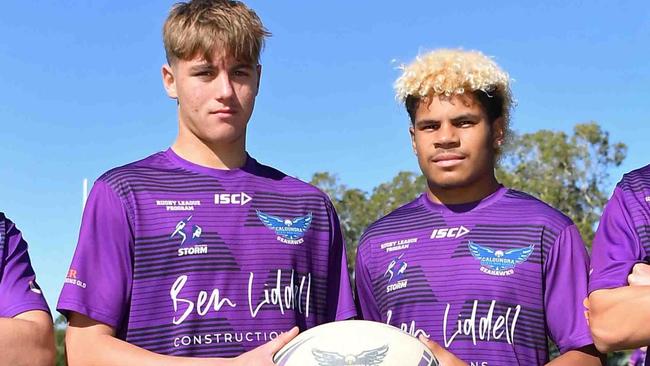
top-left (427, 174), bottom-right (499, 205)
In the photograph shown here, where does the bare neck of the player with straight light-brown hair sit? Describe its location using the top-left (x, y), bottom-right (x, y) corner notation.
top-left (172, 127), bottom-right (246, 169)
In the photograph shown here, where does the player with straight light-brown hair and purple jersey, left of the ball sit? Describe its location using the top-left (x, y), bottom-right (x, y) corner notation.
top-left (58, 0), bottom-right (355, 366)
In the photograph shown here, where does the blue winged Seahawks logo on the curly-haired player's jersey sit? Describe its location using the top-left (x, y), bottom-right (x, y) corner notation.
top-left (469, 241), bottom-right (535, 276)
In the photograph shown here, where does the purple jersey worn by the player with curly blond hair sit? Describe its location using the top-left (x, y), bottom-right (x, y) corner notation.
top-left (356, 187), bottom-right (593, 366)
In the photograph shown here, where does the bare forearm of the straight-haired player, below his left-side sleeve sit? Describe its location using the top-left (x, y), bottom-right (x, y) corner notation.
top-left (66, 329), bottom-right (233, 366)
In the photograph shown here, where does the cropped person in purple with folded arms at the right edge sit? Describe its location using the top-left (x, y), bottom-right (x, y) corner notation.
top-left (589, 165), bottom-right (650, 365)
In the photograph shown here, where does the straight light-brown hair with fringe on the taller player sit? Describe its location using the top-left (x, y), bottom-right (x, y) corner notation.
top-left (163, 0), bottom-right (271, 65)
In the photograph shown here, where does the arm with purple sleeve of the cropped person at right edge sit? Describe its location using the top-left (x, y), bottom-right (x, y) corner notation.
top-left (589, 187), bottom-right (650, 352)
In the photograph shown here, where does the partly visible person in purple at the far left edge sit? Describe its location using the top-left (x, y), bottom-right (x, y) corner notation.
top-left (0, 212), bottom-right (55, 366)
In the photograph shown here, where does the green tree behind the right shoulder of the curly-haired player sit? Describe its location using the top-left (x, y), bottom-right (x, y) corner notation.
top-left (497, 122), bottom-right (627, 247)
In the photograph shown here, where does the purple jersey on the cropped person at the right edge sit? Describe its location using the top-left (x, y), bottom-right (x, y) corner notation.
top-left (589, 165), bottom-right (650, 365)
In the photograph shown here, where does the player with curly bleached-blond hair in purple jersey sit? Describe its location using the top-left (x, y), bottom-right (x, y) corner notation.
top-left (356, 50), bottom-right (600, 366)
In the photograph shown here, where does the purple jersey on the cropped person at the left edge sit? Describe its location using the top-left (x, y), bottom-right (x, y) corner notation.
top-left (0, 212), bottom-right (50, 318)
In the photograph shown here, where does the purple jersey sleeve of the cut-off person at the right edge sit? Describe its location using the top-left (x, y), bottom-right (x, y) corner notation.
top-left (589, 187), bottom-right (644, 292)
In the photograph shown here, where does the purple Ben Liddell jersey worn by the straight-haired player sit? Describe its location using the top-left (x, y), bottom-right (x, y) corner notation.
top-left (57, 149), bottom-right (356, 357)
